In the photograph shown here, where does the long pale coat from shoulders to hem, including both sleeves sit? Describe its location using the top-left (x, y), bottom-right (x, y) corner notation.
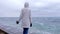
top-left (19, 8), bottom-right (31, 28)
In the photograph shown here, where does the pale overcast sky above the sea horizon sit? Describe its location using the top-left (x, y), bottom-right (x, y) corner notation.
top-left (0, 0), bottom-right (60, 17)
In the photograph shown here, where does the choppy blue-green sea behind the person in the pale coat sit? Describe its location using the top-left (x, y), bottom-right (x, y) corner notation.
top-left (0, 17), bottom-right (60, 34)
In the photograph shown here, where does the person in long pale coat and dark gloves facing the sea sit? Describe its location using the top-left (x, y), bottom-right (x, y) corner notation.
top-left (16, 2), bottom-right (32, 34)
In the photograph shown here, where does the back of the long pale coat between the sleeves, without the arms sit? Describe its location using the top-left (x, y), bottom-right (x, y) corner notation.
top-left (22, 8), bottom-right (31, 28)
